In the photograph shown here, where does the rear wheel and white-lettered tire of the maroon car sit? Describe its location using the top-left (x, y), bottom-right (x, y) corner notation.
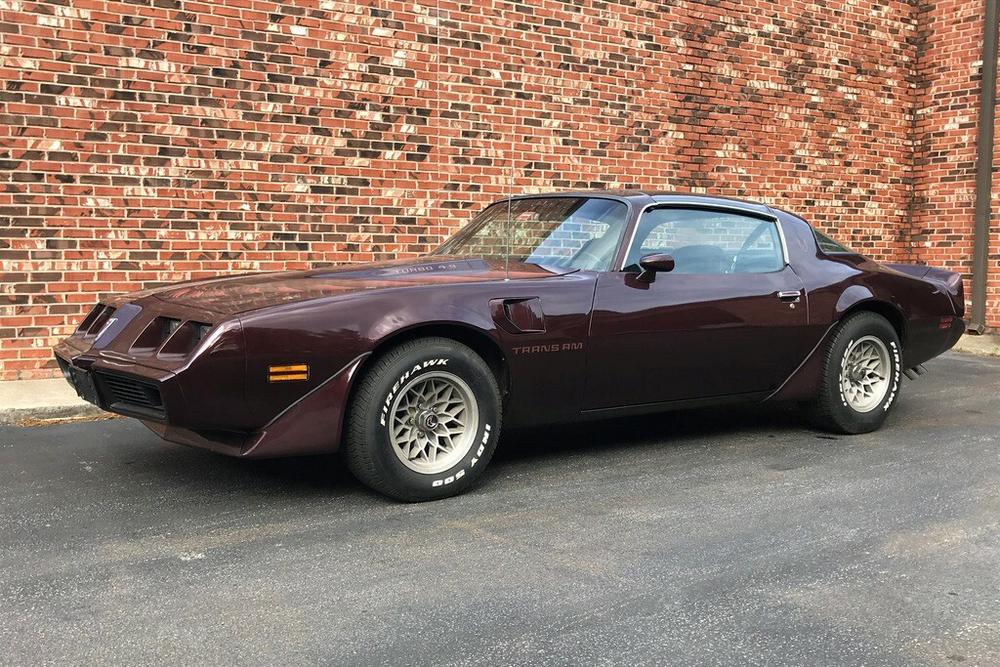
top-left (808, 312), bottom-right (903, 434)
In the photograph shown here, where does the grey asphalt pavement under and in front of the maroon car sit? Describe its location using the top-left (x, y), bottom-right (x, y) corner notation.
top-left (0, 354), bottom-right (1000, 665)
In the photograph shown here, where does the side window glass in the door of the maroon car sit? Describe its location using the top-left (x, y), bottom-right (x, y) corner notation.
top-left (626, 208), bottom-right (784, 275)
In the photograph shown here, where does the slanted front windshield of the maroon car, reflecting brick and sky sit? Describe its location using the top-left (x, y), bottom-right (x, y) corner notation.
top-left (434, 197), bottom-right (628, 271)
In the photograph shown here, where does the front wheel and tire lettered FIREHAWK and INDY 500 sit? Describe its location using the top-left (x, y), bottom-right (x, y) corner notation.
top-left (344, 338), bottom-right (501, 502)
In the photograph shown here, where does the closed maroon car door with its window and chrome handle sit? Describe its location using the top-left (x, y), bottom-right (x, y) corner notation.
top-left (584, 205), bottom-right (811, 409)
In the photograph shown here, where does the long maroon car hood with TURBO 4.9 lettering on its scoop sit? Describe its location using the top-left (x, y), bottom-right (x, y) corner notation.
top-left (112, 256), bottom-right (573, 315)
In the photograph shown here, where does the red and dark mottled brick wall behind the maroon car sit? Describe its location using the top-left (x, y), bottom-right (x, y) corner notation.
top-left (0, 0), bottom-right (996, 379)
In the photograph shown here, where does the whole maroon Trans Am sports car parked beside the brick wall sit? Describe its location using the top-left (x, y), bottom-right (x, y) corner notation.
top-left (55, 192), bottom-right (964, 500)
